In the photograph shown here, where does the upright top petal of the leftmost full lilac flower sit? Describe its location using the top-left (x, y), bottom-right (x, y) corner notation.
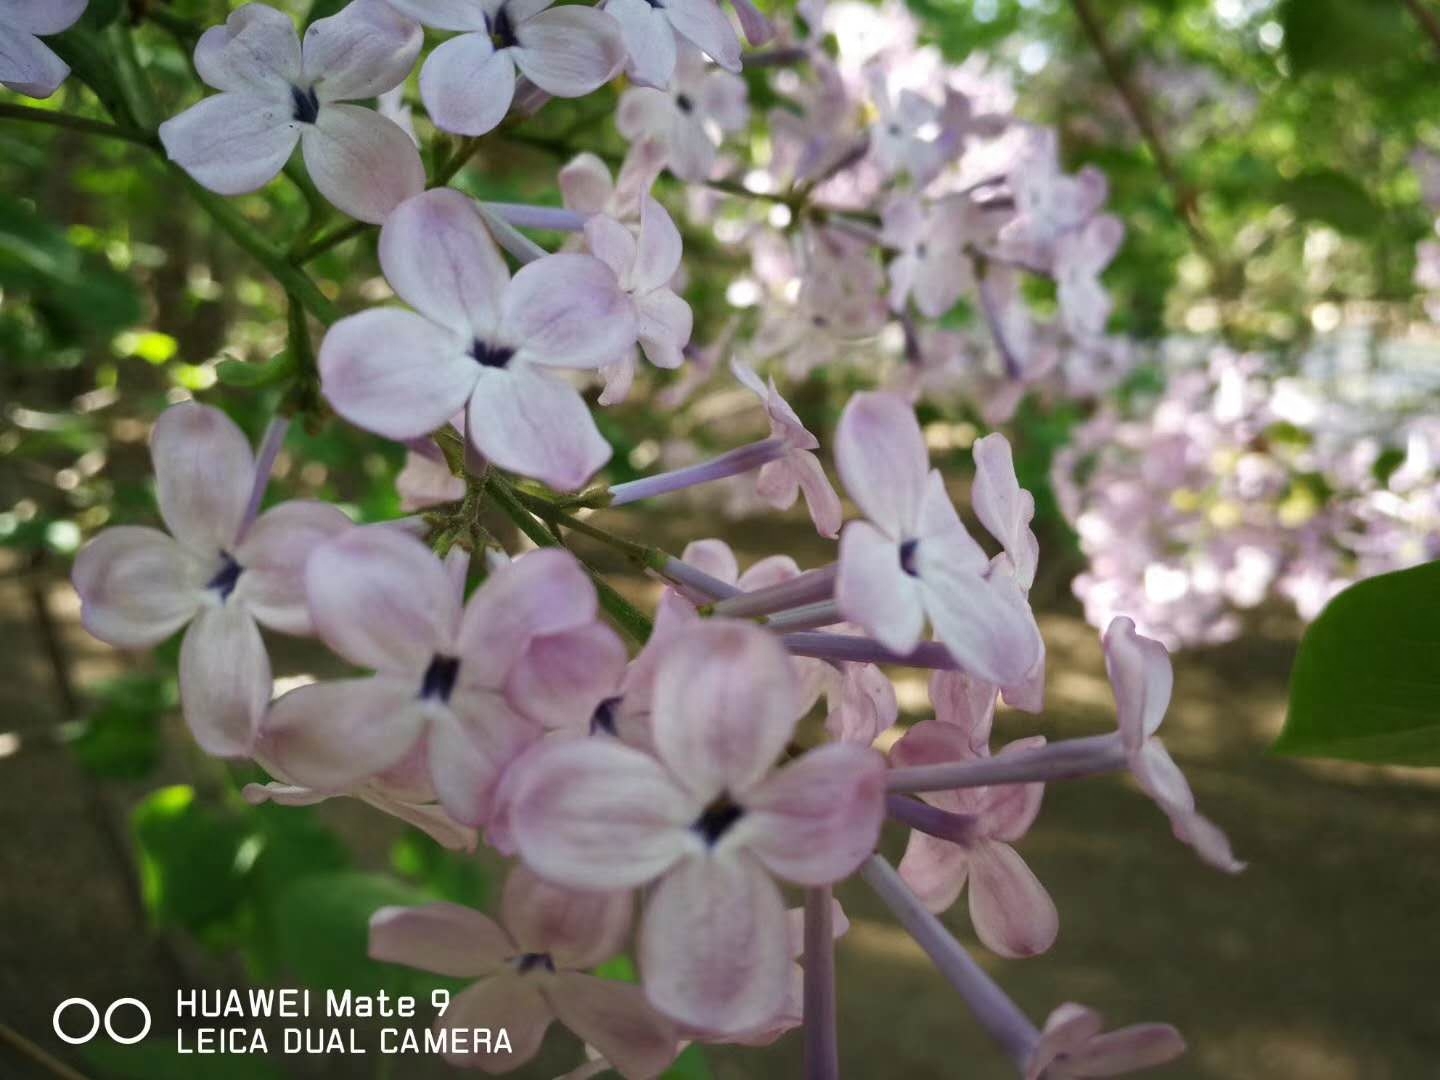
top-left (150, 402), bottom-right (255, 553)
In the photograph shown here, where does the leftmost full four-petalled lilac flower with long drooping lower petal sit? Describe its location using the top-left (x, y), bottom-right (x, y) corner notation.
top-left (71, 403), bottom-right (350, 757)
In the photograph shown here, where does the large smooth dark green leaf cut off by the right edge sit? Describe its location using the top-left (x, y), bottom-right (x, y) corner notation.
top-left (1274, 563), bottom-right (1440, 765)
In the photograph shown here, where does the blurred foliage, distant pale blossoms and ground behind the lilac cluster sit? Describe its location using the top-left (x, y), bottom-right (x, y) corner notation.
top-left (8, 0), bottom-right (1440, 1080)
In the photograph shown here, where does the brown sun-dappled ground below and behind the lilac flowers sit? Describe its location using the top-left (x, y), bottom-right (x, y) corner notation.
top-left (0, 509), bottom-right (1440, 1080)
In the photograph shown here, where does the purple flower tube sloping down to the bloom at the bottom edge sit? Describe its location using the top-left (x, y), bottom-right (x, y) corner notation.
top-left (860, 855), bottom-right (1040, 1070)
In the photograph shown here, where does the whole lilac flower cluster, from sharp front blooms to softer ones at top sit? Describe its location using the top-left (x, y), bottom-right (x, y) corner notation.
top-left (59, 0), bottom-right (1240, 1079)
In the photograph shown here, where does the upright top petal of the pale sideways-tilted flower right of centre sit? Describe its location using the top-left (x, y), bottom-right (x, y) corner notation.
top-left (835, 393), bottom-right (930, 540)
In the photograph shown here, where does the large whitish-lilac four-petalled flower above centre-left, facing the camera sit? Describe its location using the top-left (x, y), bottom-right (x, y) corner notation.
top-left (320, 189), bottom-right (636, 490)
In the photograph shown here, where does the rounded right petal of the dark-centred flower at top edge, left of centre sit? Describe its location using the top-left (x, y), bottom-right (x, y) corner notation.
top-left (513, 6), bottom-right (625, 98)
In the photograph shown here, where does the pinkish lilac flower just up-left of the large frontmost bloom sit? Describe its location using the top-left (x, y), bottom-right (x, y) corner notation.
top-left (264, 528), bottom-right (596, 825)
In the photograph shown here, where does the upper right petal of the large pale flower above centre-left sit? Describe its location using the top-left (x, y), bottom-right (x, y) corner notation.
top-left (501, 253), bottom-right (636, 369)
